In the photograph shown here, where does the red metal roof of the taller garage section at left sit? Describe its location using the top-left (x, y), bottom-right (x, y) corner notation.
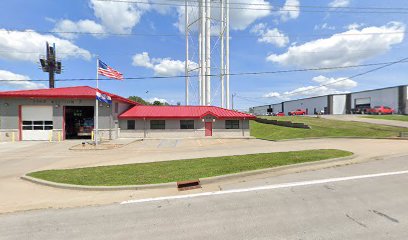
top-left (0, 86), bottom-right (141, 105)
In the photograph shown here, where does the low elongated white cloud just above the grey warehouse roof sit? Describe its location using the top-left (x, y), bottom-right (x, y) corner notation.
top-left (264, 75), bottom-right (358, 100)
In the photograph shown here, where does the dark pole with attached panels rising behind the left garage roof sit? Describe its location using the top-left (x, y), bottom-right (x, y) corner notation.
top-left (40, 42), bottom-right (62, 88)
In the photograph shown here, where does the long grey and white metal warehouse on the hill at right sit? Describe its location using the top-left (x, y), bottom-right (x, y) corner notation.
top-left (250, 85), bottom-right (408, 115)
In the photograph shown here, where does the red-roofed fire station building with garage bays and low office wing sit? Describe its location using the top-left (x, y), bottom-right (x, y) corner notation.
top-left (0, 86), bottom-right (254, 141)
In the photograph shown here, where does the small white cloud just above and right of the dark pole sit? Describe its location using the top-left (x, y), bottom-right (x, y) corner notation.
top-left (53, 19), bottom-right (105, 39)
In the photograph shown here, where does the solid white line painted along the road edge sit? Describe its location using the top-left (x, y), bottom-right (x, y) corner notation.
top-left (120, 170), bottom-right (408, 204)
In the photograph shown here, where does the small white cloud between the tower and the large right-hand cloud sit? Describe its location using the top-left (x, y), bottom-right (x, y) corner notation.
top-left (251, 23), bottom-right (289, 47)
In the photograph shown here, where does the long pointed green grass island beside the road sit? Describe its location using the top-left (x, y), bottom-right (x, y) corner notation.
top-left (28, 149), bottom-right (352, 186)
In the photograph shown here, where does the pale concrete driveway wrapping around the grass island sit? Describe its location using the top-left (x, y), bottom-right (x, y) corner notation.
top-left (0, 139), bottom-right (408, 213)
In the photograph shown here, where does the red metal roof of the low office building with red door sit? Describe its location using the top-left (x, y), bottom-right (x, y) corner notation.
top-left (119, 105), bottom-right (255, 119)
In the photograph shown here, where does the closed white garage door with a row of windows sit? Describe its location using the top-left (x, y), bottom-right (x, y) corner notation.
top-left (21, 106), bottom-right (54, 141)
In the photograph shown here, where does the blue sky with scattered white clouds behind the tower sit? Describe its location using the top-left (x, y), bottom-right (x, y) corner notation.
top-left (0, 0), bottom-right (408, 109)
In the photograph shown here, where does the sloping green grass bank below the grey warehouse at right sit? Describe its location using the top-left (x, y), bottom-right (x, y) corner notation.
top-left (250, 116), bottom-right (408, 140)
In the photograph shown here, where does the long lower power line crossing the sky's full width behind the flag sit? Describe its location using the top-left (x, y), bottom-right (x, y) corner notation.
top-left (0, 59), bottom-right (408, 82)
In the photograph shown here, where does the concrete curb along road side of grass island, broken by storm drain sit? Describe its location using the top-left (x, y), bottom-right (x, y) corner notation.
top-left (21, 154), bottom-right (357, 191)
